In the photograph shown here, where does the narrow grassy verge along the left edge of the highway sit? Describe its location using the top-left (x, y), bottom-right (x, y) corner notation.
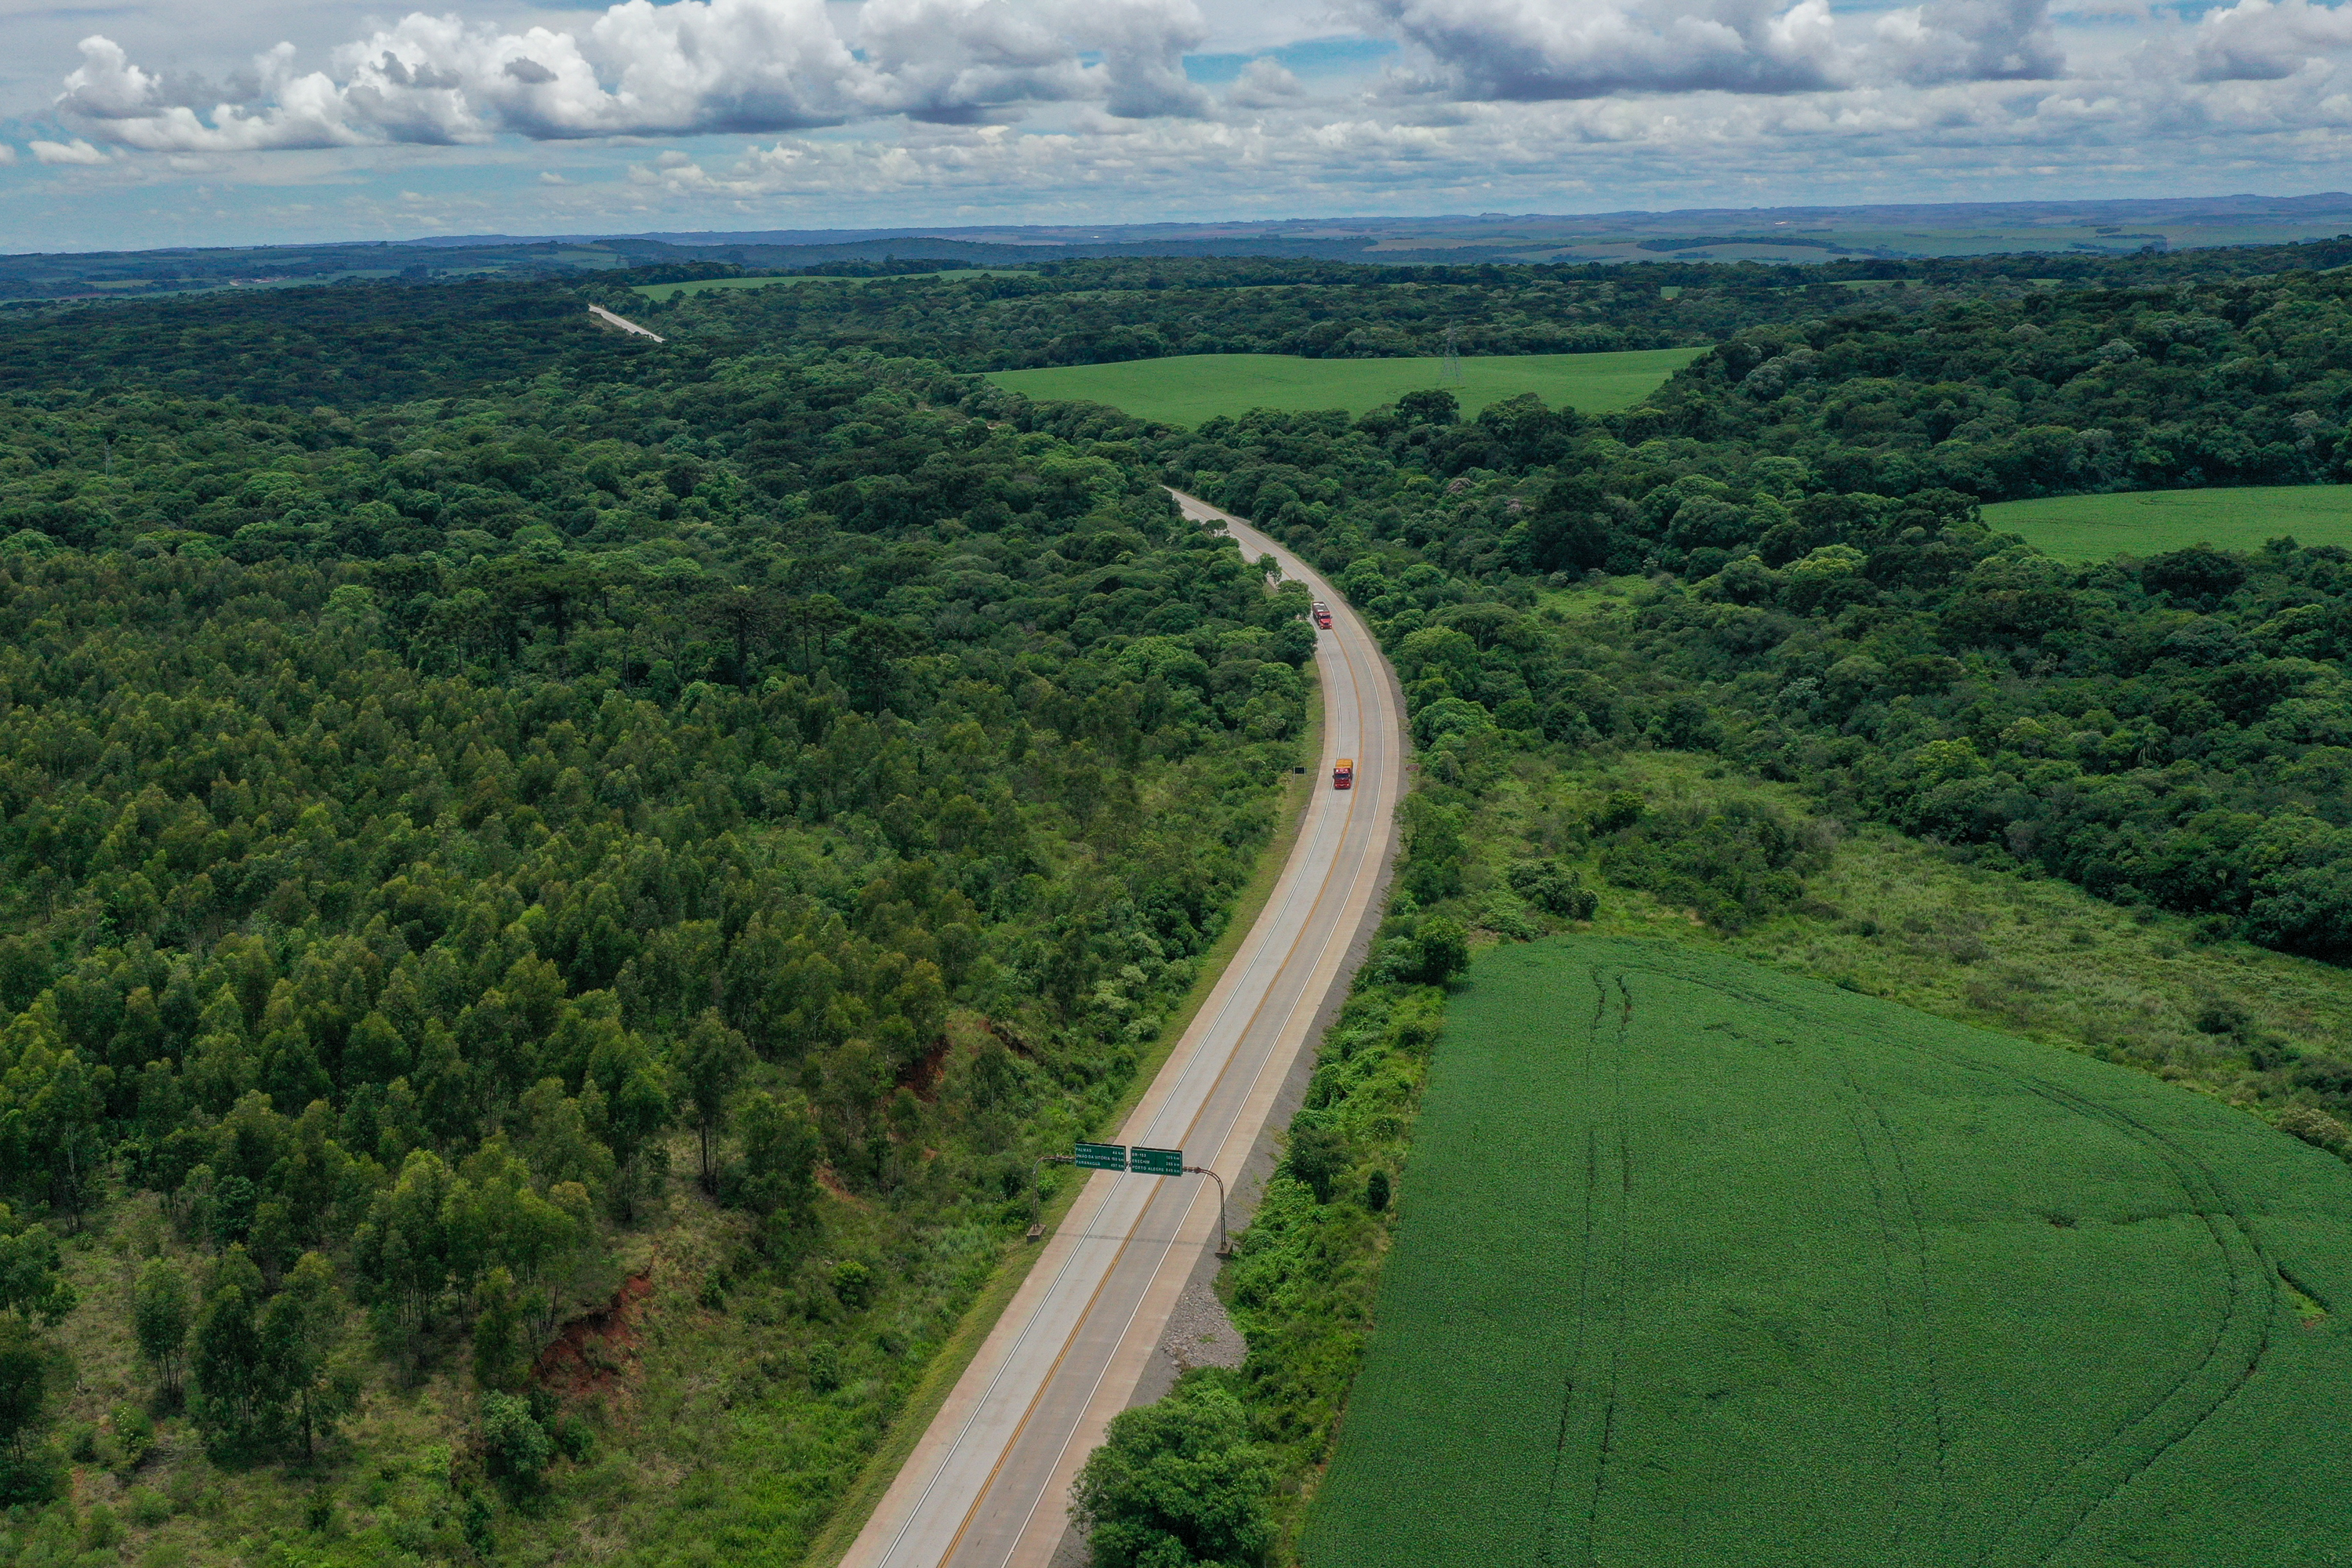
top-left (802, 666), bottom-right (1324, 1568)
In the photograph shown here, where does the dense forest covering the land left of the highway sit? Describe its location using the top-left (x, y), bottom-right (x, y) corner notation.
top-left (0, 331), bottom-right (1315, 1561)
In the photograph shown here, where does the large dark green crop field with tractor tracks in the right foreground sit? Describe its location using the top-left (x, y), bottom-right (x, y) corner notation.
top-left (1305, 938), bottom-right (2352, 1568)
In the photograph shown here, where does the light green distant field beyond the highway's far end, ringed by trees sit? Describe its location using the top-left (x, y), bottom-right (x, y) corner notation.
top-left (988, 348), bottom-right (1705, 426)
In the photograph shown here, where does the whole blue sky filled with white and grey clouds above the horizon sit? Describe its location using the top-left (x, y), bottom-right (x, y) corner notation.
top-left (0, 0), bottom-right (2352, 252)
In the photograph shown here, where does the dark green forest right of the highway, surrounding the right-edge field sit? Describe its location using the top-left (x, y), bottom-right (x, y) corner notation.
top-left (1138, 280), bottom-right (2352, 956)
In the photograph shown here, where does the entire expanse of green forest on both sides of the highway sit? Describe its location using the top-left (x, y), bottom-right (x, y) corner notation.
top-left (0, 236), bottom-right (2352, 1563)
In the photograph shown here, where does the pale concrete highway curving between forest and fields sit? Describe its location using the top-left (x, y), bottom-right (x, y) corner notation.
top-left (842, 492), bottom-right (1404, 1568)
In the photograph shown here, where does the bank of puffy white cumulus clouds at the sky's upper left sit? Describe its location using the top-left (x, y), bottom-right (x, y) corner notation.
top-left (56, 0), bottom-right (1209, 153)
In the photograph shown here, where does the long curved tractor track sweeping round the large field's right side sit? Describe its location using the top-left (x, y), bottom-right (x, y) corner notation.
top-left (1646, 971), bottom-right (2279, 1568)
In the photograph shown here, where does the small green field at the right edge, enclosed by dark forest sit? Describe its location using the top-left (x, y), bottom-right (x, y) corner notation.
top-left (1985, 485), bottom-right (2352, 562)
